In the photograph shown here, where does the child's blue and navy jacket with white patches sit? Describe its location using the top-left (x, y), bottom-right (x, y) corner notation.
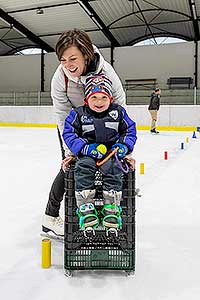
top-left (63, 103), bottom-right (137, 155)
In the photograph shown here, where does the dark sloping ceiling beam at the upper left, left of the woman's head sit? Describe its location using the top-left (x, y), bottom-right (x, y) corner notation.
top-left (0, 8), bottom-right (55, 52)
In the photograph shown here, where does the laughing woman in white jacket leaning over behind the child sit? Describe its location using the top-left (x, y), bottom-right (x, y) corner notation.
top-left (42, 29), bottom-right (125, 236)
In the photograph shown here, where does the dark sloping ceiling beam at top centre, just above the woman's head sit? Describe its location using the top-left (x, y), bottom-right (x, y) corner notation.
top-left (77, 0), bottom-right (120, 47)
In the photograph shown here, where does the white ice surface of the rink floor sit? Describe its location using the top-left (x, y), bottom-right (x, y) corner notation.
top-left (0, 127), bottom-right (200, 300)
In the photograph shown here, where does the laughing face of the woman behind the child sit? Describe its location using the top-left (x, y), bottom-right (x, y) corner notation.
top-left (60, 46), bottom-right (86, 77)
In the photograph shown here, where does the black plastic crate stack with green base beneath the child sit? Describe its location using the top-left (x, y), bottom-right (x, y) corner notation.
top-left (64, 165), bottom-right (135, 275)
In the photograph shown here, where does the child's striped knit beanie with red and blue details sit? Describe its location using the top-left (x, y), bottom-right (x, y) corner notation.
top-left (85, 74), bottom-right (112, 104)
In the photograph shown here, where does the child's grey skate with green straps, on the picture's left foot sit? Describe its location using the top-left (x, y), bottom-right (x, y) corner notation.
top-left (77, 203), bottom-right (99, 238)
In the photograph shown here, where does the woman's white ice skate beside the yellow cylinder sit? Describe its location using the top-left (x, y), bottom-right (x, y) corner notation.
top-left (42, 214), bottom-right (64, 237)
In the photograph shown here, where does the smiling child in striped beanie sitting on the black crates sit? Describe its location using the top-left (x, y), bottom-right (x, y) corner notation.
top-left (63, 74), bottom-right (137, 237)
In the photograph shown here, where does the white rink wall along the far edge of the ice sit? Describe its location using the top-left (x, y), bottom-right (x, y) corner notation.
top-left (0, 105), bottom-right (200, 126)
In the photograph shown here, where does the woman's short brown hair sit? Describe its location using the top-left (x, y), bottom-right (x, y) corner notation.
top-left (56, 29), bottom-right (94, 63)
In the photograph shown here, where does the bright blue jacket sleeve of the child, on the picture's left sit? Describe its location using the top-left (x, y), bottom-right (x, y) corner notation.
top-left (62, 109), bottom-right (86, 155)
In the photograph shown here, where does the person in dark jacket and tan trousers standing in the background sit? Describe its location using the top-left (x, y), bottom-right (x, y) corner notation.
top-left (148, 88), bottom-right (161, 133)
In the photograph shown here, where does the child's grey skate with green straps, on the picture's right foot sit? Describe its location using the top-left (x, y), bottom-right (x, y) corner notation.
top-left (102, 204), bottom-right (122, 237)
